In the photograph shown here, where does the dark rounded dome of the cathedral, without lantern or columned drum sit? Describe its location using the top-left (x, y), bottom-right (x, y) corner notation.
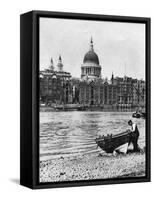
top-left (83, 50), bottom-right (99, 65)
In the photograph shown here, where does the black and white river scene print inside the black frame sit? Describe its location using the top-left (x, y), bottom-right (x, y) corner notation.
top-left (39, 17), bottom-right (147, 183)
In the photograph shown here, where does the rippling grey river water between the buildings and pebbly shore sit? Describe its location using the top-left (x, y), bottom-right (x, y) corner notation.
top-left (40, 111), bottom-right (145, 160)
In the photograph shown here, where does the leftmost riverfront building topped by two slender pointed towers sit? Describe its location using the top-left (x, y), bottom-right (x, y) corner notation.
top-left (40, 56), bottom-right (72, 105)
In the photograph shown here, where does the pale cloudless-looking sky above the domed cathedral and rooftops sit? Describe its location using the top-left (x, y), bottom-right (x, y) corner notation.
top-left (40, 18), bottom-right (145, 80)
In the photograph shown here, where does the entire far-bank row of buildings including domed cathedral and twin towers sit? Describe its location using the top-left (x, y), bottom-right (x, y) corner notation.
top-left (40, 39), bottom-right (146, 110)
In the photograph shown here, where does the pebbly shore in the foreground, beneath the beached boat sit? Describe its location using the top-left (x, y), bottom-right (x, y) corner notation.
top-left (40, 153), bottom-right (145, 182)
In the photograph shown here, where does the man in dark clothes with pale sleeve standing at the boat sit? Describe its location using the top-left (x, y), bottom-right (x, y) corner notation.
top-left (128, 120), bottom-right (140, 151)
